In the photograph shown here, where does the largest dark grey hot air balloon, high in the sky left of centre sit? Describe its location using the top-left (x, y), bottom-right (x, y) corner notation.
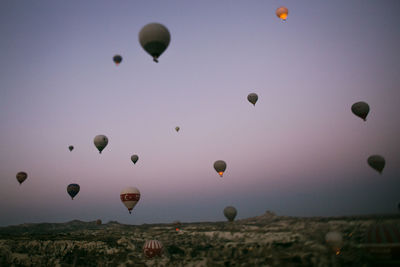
top-left (139, 23), bottom-right (171, 62)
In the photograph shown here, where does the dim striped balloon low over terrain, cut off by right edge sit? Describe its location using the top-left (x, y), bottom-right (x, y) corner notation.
top-left (361, 223), bottom-right (400, 266)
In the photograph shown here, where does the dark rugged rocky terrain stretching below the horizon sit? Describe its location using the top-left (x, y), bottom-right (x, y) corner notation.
top-left (0, 212), bottom-right (400, 266)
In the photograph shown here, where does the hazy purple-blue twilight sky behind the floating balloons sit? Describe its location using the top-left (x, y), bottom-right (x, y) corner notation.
top-left (0, 0), bottom-right (400, 226)
